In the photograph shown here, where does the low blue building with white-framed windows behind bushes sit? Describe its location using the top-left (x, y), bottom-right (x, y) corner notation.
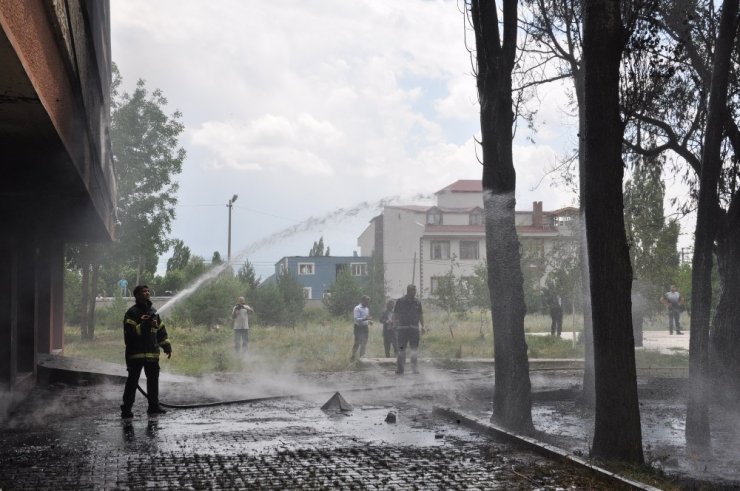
top-left (275, 255), bottom-right (372, 305)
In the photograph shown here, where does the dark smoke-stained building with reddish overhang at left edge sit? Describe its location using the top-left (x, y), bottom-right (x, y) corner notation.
top-left (0, 0), bottom-right (116, 395)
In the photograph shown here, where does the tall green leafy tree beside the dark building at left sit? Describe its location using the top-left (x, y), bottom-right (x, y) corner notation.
top-left (68, 64), bottom-right (185, 339)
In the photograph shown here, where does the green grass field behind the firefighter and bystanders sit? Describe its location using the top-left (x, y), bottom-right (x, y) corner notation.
top-left (64, 312), bottom-right (688, 375)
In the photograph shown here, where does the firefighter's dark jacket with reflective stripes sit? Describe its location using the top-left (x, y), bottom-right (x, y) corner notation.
top-left (123, 300), bottom-right (172, 362)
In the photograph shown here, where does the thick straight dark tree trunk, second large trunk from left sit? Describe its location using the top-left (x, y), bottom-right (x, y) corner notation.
top-left (583, 0), bottom-right (644, 464)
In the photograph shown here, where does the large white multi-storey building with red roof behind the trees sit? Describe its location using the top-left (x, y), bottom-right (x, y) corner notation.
top-left (357, 180), bottom-right (579, 298)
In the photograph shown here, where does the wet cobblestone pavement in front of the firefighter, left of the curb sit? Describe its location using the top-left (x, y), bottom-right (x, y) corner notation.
top-left (0, 373), bottom-right (613, 490)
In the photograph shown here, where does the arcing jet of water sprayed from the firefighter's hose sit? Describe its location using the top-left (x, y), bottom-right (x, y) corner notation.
top-left (159, 194), bottom-right (431, 314)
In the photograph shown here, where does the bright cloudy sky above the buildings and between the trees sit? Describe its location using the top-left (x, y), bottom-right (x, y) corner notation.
top-left (111, 0), bottom-right (688, 279)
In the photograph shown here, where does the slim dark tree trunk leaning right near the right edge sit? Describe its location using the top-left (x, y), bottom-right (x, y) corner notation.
top-left (686, 0), bottom-right (738, 446)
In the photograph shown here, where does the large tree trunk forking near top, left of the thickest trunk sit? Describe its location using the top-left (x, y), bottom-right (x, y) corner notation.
top-left (471, 0), bottom-right (534, 433)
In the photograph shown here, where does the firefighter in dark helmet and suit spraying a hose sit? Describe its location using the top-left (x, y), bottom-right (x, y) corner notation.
top-left (121, 285), bottom-right (172, 418)
